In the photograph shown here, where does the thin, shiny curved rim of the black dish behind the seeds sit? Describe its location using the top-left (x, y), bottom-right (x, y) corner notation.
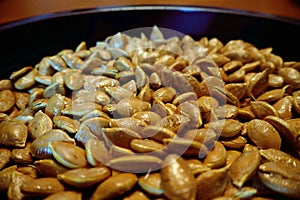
top-left (0, 5), bottom-right (300, 32)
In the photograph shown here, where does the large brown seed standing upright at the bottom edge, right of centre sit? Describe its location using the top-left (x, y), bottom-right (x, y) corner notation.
top-left (161, 154), bottom-right (196, 200)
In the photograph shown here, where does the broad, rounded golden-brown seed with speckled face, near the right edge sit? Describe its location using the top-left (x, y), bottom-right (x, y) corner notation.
top-left (247, 119), bottom-right (281, 149)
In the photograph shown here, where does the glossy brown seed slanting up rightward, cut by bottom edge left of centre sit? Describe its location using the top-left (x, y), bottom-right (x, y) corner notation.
top-left (90, 173), bottom-right (138, 200)
